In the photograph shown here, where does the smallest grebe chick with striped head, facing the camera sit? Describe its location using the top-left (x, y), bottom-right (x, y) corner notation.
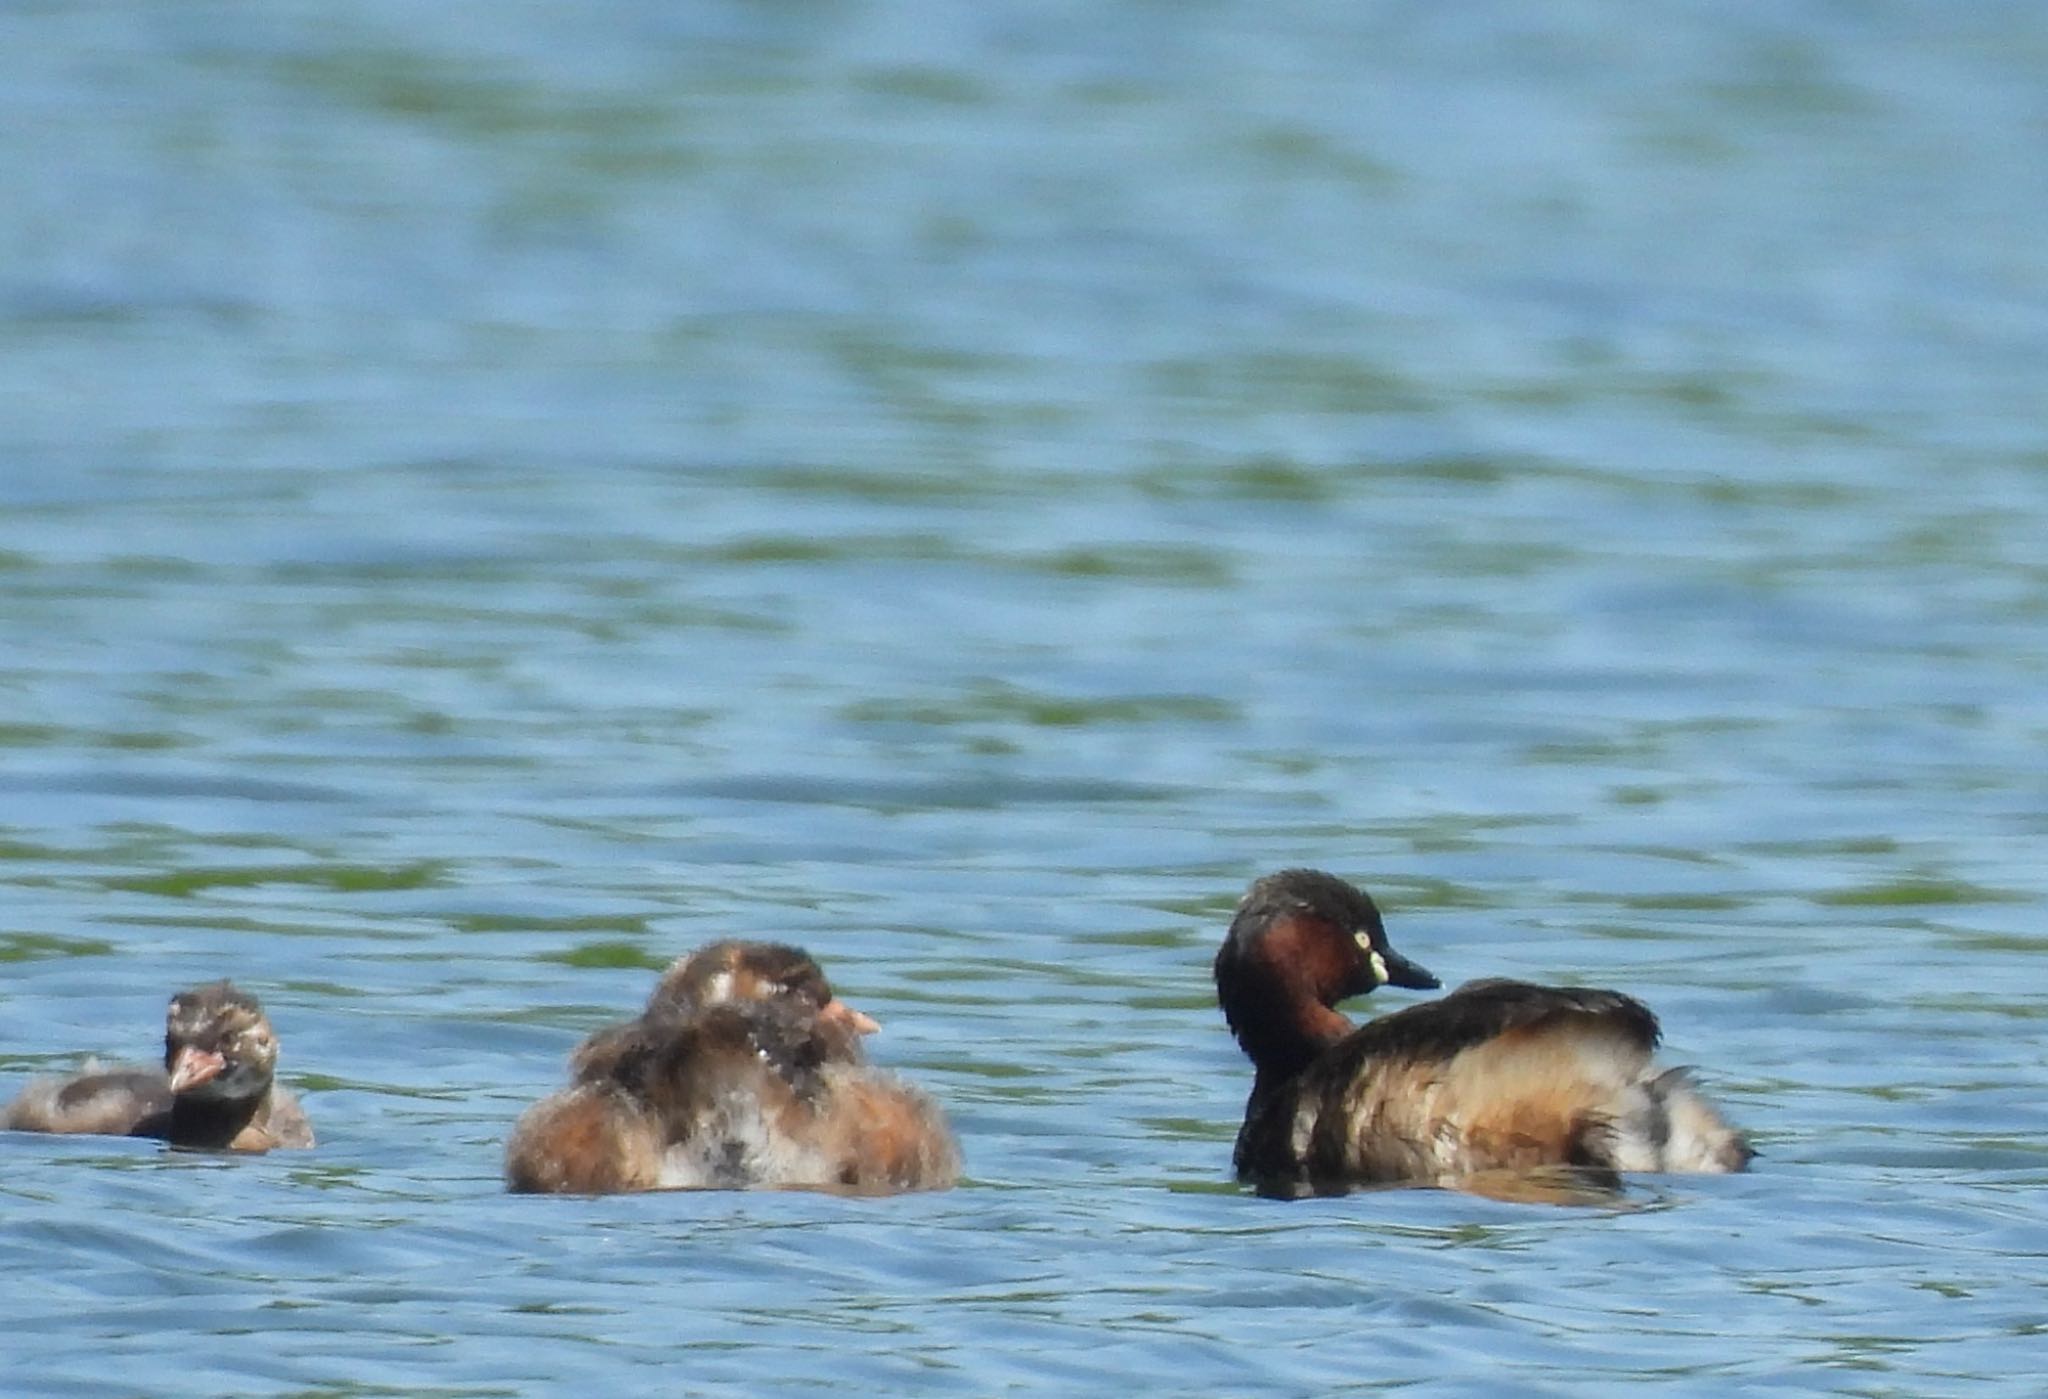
top-left (0, 981), bottom-right (313, 1151)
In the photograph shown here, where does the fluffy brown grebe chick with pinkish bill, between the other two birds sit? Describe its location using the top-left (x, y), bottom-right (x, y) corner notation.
top-left (506, 942), bottom-right (961, 1194)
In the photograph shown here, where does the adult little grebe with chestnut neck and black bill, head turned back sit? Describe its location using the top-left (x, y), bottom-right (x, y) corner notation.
top-left (1217, 868), bottom-right (1751, 1192)
